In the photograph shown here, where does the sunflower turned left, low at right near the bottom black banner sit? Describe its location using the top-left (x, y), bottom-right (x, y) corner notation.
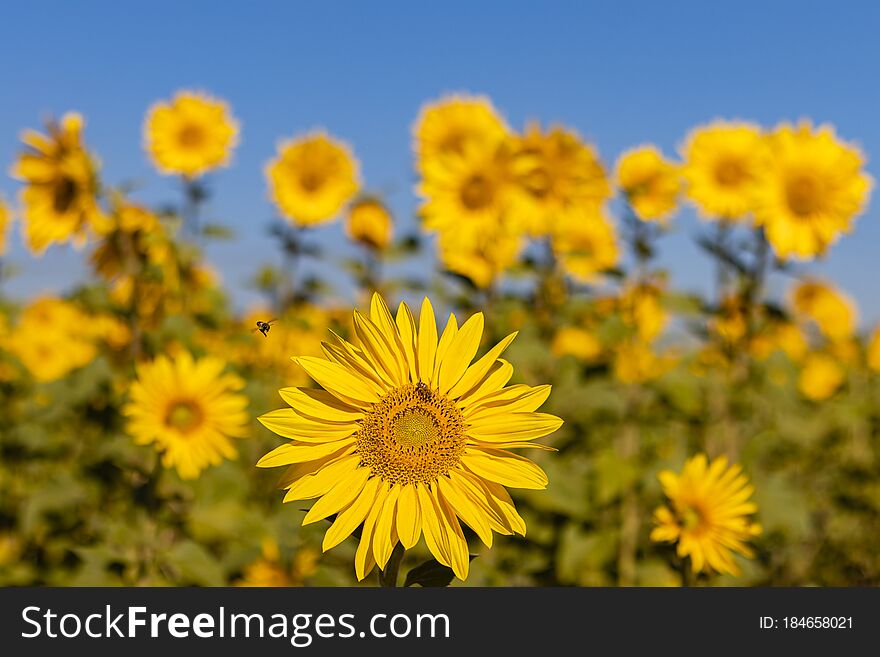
top-left (651, 454), bottom-right (761, 575)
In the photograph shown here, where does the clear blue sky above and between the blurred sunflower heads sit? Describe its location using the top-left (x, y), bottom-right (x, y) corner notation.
top-left (0, 0), bottom-right (880, 323)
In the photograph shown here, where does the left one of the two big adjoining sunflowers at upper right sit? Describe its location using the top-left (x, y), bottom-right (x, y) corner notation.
top-left (682, 121), bottom-right (769, 221)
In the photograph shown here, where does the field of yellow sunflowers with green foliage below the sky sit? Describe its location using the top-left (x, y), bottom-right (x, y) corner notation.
top-left (0, 90), bottom-right (880, 586)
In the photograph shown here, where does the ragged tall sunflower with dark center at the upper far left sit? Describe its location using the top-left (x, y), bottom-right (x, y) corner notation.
top-left (10, 112), bottom-right (106, 254)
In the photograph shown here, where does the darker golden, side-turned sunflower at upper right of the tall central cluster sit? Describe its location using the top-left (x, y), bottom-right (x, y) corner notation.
top-left (512, 123), bottom-right (611, 236)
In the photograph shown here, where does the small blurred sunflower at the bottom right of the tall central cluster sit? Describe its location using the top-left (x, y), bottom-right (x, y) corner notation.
top-left (551, 208), bottom-right (620, 283)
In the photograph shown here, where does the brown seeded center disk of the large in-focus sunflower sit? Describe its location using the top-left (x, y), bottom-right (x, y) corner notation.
top-left (357, 384), bottom-right (467, 485)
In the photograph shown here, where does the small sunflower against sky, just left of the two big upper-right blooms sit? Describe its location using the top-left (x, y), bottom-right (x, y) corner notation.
top-left (615, 145), bottom-right (681, 223)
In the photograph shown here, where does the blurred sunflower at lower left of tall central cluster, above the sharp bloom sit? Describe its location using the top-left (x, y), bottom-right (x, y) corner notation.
top-left (437, 219), bottom-right (523, 289)
